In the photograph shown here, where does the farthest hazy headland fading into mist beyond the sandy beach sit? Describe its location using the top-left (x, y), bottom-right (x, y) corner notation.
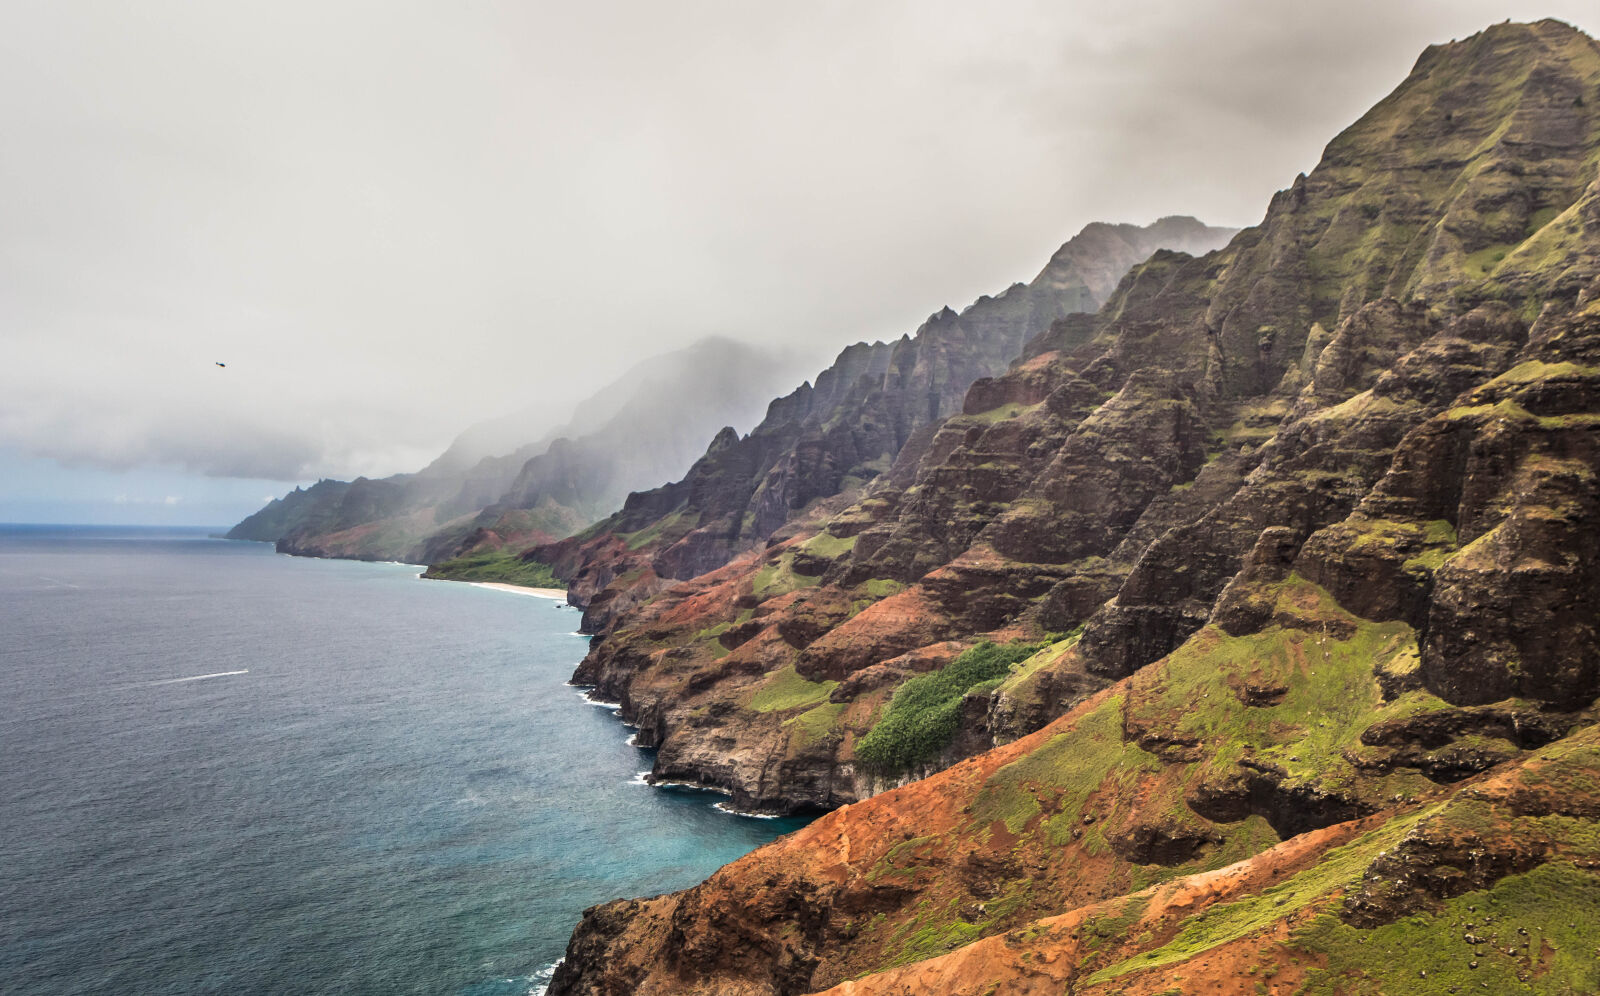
top-left (229, 338), bottom-right (789, 564)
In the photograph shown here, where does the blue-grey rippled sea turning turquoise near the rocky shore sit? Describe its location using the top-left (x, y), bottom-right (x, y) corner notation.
top-left (0, 527), bottom-right (798, 996)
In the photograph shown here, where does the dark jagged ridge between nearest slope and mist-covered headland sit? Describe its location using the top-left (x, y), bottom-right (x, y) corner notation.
top-left (533, 218), bottom-right (1232, 629)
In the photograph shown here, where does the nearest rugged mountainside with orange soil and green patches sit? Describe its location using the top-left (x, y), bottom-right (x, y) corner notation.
top-left (552, 21), bottom-right (1600, 996)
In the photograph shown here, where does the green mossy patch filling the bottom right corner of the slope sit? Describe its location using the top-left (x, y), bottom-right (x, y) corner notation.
top-left (1293, 861), bottom-right (1600, 996)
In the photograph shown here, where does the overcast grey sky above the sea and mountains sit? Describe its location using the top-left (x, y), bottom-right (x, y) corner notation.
top-left (0, 0), bottom-right (1600, 524)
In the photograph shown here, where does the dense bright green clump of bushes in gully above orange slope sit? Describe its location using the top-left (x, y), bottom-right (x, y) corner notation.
top-left (856, 641), bottom-right (1040, 772)
